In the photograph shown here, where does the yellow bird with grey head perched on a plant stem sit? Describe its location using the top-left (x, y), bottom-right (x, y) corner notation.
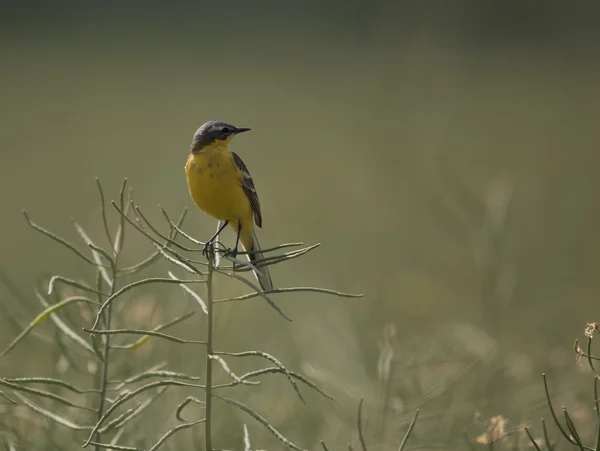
top-left (185, 121), bottom-right (273, 290)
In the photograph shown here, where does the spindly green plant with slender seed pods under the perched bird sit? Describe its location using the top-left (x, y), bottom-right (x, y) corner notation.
top-left (0, 180), bottom-right (372, 451)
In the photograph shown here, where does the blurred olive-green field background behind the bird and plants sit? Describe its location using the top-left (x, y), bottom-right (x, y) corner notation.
top-left (0, 0), bottom-right (600, 449)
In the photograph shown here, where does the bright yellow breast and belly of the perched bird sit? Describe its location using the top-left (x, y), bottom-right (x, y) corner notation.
top-left (185, 146), bottom-right (252, 221)
